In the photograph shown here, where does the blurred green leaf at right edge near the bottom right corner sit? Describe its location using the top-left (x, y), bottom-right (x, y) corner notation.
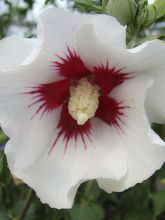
top-left (153, 189), bottom-right (165, 217)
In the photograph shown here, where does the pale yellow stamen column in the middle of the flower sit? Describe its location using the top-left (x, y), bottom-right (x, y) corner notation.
top-left (68, 78), bottom-right (99, 125)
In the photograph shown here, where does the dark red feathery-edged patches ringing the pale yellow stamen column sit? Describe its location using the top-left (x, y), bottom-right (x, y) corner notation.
top-left (28, 48), bottom-right (130, 150)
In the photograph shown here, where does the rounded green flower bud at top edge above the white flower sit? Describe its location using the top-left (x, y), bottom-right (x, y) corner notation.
top-left (107, 0), bottom-right (138, 25)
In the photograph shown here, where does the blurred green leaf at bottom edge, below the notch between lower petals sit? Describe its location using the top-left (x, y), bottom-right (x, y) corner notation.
top-left (69, 202), bottom-right (104, 220)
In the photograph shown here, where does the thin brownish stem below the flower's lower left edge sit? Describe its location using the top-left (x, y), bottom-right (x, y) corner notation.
top-left (18, 189), bottom-right (34, 220)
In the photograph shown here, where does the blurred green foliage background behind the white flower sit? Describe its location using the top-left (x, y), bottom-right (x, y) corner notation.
top-left (0, 0), bottom-right (165, 220)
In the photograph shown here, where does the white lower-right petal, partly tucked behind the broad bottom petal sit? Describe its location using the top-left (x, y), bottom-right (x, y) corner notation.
top-left (98, 77), bottom-right (165, 192)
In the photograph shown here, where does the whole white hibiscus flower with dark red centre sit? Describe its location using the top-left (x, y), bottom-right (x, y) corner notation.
top-left (0, 8), bottom-right (165, 208)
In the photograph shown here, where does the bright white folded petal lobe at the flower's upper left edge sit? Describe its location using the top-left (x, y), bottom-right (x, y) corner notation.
top-left (0, 35), bottom-right (36, 71)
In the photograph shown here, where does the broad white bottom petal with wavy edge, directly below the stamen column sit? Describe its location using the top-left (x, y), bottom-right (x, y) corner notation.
top-left (5, 108), bottom-right (127, 208)
